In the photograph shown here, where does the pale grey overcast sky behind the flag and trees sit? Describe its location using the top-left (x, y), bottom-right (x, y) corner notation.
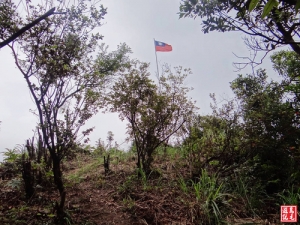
top-left (0, 0), bottom-right (278, 162)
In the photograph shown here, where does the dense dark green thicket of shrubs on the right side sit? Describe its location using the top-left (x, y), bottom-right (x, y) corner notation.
top-left (178, 51), bottom-right (300, 217)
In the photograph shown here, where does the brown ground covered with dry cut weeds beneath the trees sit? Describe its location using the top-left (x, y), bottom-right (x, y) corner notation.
top-left (0, 153), bottom-right (278, 225)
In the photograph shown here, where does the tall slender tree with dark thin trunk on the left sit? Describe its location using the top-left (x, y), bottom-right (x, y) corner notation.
top-left (0, 0), bottom-right (130, 222)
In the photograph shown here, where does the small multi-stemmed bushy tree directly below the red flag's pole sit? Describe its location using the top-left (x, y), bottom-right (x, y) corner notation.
top-left (106, 61), bottom-right (195, 174)
